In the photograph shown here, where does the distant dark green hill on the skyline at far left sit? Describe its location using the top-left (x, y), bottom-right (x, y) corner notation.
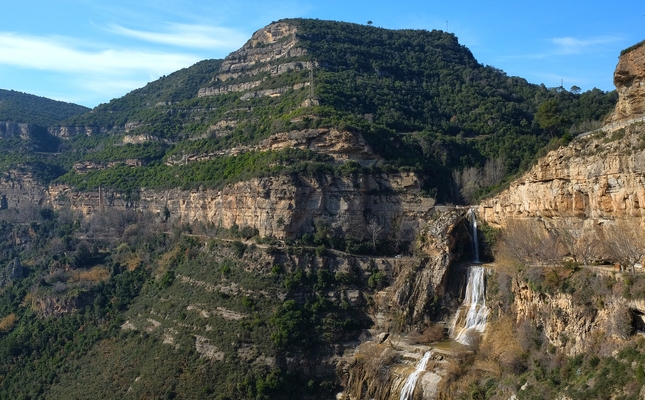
top-left (0, 89), bottom-right (89, 127)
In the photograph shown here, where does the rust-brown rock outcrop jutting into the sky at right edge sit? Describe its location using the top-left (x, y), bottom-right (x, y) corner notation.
top-left (610, 42), bottom-right (645, 122)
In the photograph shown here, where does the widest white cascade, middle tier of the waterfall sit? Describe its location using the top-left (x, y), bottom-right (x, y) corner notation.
top-left (449, 266), bottom-right (488, 345)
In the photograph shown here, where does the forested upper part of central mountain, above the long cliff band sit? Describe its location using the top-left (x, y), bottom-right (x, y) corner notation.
top-left (2, 19), bottom-right (616, 202)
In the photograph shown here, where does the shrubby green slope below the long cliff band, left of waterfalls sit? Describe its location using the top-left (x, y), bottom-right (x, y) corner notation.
top-left (0, 207), bottom-right (386, 399)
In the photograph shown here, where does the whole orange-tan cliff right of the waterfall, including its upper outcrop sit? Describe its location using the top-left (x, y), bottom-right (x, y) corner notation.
top-left (479, 46), bottom-right (645, 266)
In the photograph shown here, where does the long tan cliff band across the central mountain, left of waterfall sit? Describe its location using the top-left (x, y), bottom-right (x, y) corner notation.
top-left (46, 173), bottom-right (434, 240)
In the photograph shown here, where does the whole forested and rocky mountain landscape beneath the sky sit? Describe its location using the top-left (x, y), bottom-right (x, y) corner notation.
top-left (0, 19), bottom-right (645, 399)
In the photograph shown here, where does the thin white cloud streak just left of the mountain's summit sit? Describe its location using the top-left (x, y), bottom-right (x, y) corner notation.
top-left (104, 23), bottom-right (248, 50)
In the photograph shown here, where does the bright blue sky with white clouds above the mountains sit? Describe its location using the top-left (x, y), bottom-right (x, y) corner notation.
top-left (0, 0), bottom-right (645, 107)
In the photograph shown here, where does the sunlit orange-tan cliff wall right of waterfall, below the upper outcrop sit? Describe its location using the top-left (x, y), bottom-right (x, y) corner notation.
top-left (479, 125), bottom-right (645, 226)
